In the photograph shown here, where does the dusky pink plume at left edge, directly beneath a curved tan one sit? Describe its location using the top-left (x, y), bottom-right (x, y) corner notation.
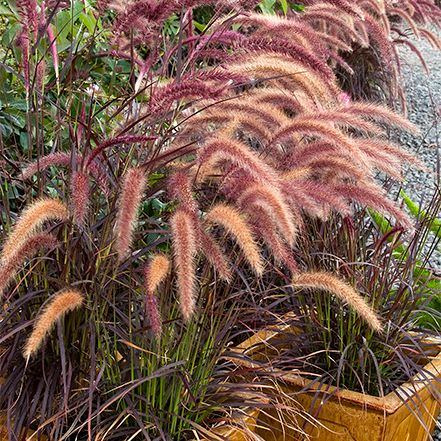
top-left (0, 233), bottom-right (59, 298)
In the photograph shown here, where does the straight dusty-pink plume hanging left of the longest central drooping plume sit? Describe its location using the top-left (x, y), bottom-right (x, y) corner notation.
top-left (115, 168), bottom-right (147, 260)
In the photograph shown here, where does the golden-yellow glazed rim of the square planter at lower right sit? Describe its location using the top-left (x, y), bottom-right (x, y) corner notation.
top-left (227, 316), bottom-right (441, 414)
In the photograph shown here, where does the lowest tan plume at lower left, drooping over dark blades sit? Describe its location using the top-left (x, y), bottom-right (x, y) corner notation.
top-left (23, 290), bottom-right (83, 359)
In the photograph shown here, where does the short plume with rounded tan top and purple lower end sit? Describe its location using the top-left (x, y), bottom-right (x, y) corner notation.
top-left (144, 254), bottom-right (170, 338)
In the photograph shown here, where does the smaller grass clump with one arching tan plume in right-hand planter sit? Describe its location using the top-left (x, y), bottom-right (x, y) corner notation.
top-left (238, 188), bottom-right (441, 402)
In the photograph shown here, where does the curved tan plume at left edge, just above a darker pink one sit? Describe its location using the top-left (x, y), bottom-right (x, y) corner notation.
top-left (0, 198), bottom-right (68, 263)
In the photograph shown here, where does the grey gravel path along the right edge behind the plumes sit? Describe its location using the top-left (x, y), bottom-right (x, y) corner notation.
top-left (400, 30), bottom-right (441, 270)
